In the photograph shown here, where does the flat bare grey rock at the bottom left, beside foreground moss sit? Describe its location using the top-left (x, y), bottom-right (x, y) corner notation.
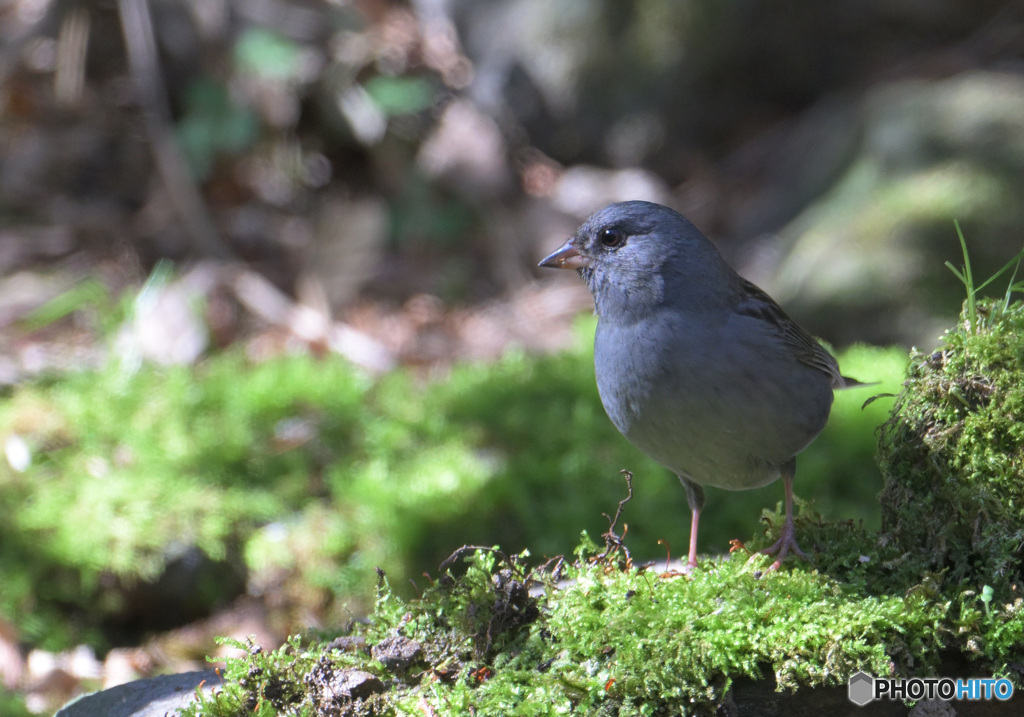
top-left (54, 670), bottom-right (220, 717)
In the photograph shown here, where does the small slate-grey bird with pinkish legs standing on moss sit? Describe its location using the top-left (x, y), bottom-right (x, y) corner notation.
top-left (540, 201), bottom-right (859, 573)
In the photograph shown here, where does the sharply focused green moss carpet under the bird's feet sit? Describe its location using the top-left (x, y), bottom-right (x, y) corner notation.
top-left (186, 544), bottom-right (1007, 717)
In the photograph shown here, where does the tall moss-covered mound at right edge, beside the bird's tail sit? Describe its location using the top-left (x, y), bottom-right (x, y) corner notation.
top-left (880, 302), bottom-right (1024, 599)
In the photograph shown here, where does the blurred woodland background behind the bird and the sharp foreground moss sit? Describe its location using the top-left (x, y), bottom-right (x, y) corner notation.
top-left (0, 0), bottom-right (1024, 714)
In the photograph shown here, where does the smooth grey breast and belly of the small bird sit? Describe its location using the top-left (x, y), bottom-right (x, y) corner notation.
top-left (594, 315), bottom-right (831, 490)
